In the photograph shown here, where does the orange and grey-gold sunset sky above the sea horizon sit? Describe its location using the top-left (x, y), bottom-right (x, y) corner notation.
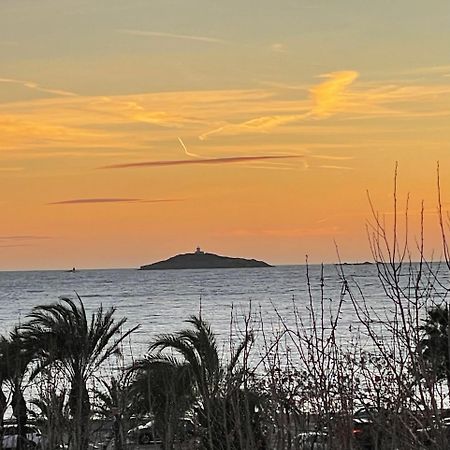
top-left (0, 0), bottom-right (450, 270)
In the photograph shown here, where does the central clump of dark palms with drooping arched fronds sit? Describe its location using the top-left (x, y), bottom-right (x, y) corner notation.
top-left (126, 316), bottom-right (262, 449)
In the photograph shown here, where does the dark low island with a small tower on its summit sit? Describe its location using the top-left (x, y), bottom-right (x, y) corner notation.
top-left (140, 247), bottom-right (272, 270)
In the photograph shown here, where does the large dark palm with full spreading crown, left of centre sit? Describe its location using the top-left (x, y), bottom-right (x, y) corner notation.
top-left (20, 295), bottom-right (137, 450)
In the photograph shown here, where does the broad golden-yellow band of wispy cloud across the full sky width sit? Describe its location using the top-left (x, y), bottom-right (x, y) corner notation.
top-left (0, 71), bottom-right (450, 164)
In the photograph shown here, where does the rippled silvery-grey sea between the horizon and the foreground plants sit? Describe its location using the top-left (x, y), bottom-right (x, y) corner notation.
top-left (0, 265), bottom-right (442, 356)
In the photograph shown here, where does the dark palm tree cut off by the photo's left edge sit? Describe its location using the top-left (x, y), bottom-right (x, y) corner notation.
top-left (0, 329), bottom-right (34, 450)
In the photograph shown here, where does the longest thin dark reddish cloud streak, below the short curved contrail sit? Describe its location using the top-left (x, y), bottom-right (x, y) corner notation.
top-left (98, 155), bottom-right (303, 169)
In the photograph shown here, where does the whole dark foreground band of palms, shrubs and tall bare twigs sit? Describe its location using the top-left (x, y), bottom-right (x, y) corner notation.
top-left (0, 167), bottom-right (450, 450)
